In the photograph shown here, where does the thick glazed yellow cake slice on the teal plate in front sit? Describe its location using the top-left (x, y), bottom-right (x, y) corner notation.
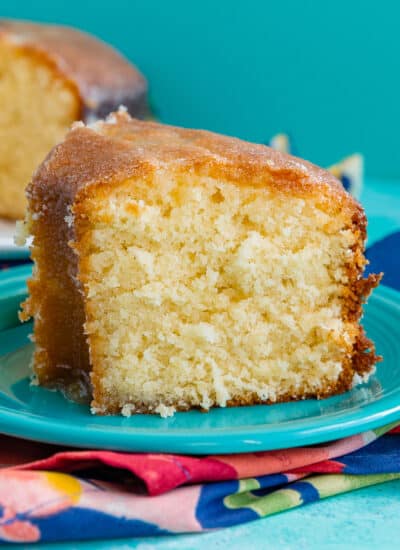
top-left (18, 112), bottom-right (380, 416)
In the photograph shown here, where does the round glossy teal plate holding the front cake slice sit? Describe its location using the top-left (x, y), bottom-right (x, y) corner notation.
top-left (0, 268), bottom-right (400, 454)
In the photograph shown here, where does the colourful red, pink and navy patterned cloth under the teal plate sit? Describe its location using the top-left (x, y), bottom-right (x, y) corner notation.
top-left (0, 144), bottom-right (400, 544)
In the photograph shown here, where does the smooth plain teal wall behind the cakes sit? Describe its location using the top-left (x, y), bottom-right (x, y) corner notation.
top-left (0, 0), bottom-right (400, 178)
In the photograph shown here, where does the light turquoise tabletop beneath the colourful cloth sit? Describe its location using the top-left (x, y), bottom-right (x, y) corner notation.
top-left (3, 180), bottom-right (400, 550)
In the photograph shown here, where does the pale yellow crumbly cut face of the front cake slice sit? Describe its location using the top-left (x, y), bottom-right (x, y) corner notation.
top-left (79, 174), bottom-right (368, 413)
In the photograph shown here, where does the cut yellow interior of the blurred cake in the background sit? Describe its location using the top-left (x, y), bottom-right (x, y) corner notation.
top-left (0, 41), bottom-right (80, 218)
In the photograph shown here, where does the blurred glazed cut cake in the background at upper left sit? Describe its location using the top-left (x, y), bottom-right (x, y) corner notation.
top-left (0, 20), bottom-right (147, 219)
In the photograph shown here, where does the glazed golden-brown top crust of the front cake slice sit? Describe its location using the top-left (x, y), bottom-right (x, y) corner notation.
top-left (28, 109), bottom-right (365, 233)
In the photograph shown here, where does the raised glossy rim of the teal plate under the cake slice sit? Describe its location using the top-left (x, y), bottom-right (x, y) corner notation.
top-left (0, 274), bottom-right (400, 455)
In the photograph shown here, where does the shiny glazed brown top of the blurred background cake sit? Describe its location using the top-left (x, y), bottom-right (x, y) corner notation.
top-left (0, 19), bottom-right (147, 115)
